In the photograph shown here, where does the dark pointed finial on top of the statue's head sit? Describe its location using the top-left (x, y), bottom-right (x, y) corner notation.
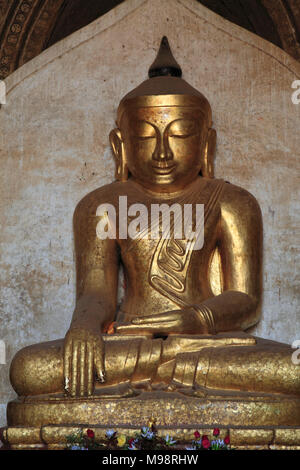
top-left (148, 36), bottom-right (182, 78)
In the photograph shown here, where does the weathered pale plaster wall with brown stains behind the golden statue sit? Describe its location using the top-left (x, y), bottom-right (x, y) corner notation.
top-left (0, 0), bottom-right (300, 425)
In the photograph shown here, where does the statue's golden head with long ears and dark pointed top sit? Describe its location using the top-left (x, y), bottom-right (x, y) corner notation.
top-left (110, 37), bottom-right (216, 192)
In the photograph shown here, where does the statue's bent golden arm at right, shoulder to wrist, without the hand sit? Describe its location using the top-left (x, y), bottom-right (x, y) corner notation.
top-left (202, 184), bottom-right (262, 332)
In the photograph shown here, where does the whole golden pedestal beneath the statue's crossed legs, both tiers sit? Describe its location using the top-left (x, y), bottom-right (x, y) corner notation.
top-left (3, 390), bottom-right (300, 449)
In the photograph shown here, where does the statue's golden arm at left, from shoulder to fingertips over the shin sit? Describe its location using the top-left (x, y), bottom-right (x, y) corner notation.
top-left (64, 193), bottom-right (118, 396)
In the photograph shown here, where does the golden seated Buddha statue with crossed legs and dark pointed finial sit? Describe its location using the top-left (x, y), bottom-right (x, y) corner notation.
top-left (8, 38), bottom-right (300, 448)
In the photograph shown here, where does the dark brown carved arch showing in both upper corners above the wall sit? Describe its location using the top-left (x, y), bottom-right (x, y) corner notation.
top-left (0, 0), bottom-right (300, 79)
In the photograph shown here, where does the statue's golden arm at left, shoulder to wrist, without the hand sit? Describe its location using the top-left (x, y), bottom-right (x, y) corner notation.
top-left (71, 196), bottom-right (119, 330)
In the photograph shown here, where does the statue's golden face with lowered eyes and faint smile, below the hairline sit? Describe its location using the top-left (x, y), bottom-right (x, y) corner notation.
top-left (120, 106), bottom-right (208, 192)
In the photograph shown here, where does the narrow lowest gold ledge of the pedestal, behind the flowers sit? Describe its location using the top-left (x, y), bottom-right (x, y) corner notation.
top-left (2, 425), bottom-right (300, 450)
